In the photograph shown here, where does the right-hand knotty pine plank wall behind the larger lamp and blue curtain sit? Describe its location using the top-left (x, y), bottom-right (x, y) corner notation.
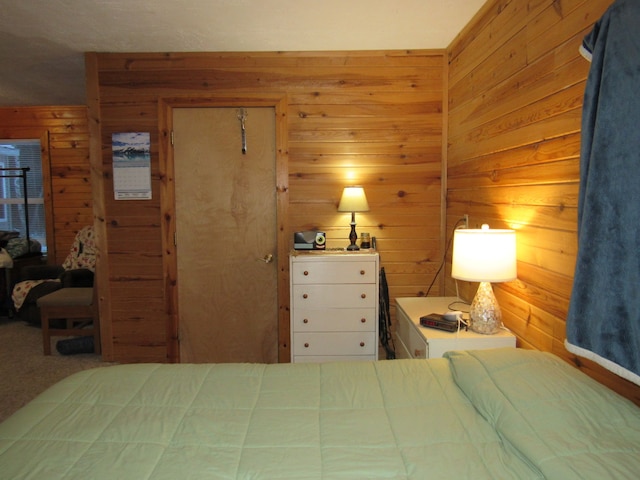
top-left (446, 0), bottom-right (640, 404)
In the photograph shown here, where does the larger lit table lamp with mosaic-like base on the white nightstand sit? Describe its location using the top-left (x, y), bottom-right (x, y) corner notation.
top-left (451, 224), bottom-right (517, 334)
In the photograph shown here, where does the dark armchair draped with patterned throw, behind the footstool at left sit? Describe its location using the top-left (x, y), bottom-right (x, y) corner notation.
top-left (11, 226), bottom-right (96, 325)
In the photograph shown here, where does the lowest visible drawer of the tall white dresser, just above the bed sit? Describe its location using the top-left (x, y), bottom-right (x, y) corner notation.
top-left (293, 332), bottom-right (378, 355)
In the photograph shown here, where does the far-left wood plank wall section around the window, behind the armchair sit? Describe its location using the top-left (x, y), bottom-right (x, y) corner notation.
top-left (0, 106), bottom-right (93, 264)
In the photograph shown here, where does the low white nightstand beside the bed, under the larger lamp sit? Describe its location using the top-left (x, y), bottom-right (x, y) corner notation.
top-left (396, 297), bottom-right (516, 358)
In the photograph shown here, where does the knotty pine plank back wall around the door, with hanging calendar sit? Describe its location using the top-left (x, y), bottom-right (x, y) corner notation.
top-left (87, 51), bottom-right (446, 361)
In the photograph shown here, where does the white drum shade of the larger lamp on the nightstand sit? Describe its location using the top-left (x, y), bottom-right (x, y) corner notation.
top-left (451, 225), bottom-right (518, 282)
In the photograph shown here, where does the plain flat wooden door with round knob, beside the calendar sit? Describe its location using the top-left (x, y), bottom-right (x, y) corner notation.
top-left (173, 107), bottom-right (278, 363)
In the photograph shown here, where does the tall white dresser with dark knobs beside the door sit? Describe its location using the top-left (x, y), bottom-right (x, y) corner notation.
top-left (289, 250), bottom-right (380, 363)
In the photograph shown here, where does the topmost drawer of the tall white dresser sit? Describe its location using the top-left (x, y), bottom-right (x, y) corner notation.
top-left (291, 261), bottom-right (378, 284)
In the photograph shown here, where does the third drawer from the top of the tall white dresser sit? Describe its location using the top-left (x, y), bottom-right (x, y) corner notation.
top-left (291, 308), bottom-right (378, 332)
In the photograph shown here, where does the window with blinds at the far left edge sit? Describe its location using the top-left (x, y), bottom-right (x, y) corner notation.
top-left (0, 139), bottom-right (47, 253)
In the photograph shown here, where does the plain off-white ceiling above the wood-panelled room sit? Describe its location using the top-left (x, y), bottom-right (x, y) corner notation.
top-left (0, 0), bottom-right (486, 106)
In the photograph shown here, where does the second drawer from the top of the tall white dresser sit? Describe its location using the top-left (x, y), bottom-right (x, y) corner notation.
top-left (291, 283), bottom-right (377, 311)
